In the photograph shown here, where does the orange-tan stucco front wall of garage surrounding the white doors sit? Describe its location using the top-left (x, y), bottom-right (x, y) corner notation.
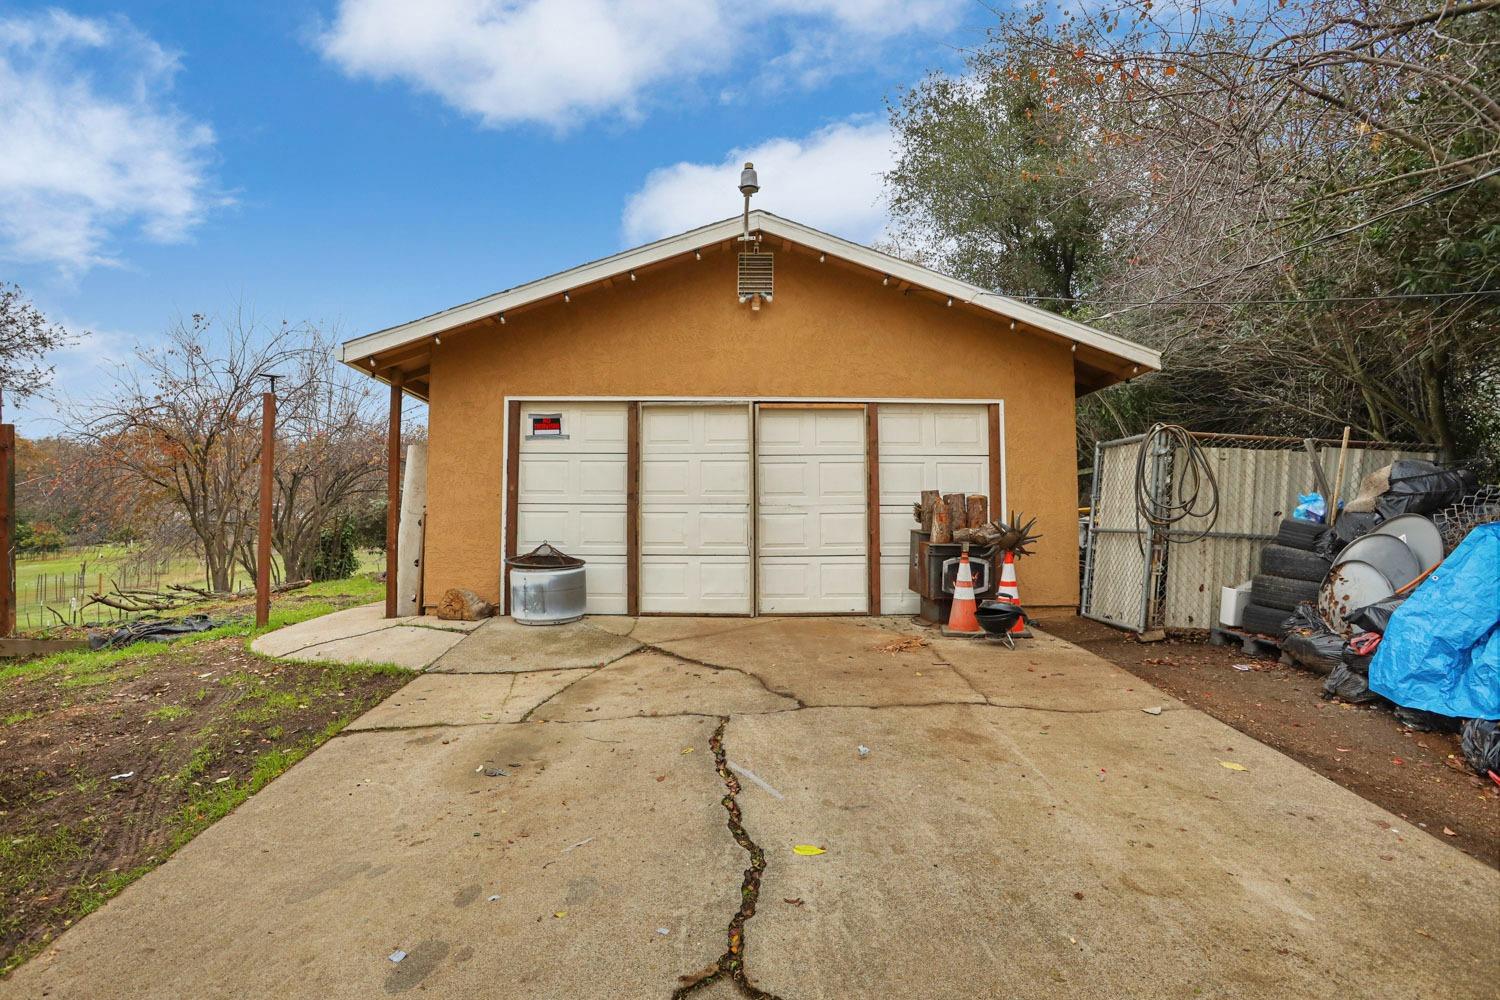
top-left (425, 252), bottom-right (1079, 606)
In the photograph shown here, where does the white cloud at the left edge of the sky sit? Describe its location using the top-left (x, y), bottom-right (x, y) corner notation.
top-left (0, 10), bottom-right (222, 271)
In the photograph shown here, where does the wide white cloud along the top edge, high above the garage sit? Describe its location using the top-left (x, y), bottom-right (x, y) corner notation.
top-left (320, 0), bottom-right (969, 129)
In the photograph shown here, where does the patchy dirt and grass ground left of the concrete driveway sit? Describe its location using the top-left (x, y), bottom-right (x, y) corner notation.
top-left (0, 636), bottom-right (411, 972)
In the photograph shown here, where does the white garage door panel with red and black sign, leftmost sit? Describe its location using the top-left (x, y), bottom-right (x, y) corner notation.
top-left (516, 402), bottom-right (629, 615)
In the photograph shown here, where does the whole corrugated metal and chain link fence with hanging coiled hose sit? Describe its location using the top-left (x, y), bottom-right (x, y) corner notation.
top-left (1080, 432), bottom-right (1434, 633)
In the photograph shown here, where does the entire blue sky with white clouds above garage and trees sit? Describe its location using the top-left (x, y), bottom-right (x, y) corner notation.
top-left (0, 0), bottom-right (989, 433)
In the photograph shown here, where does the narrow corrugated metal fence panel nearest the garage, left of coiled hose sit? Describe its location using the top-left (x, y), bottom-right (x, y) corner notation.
top-left (1085, 441), bottom-right (1146, 628)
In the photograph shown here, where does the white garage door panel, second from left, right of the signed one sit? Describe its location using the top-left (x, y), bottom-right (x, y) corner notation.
top-left (641, 403), bottom-right (753, 615)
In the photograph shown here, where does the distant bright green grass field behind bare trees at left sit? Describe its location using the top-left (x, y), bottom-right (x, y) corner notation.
top-left (15, 544), bottom-right (384, 628)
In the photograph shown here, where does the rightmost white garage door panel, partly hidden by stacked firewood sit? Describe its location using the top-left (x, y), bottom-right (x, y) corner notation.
top-left (879, 403), bottom-right (990, 615)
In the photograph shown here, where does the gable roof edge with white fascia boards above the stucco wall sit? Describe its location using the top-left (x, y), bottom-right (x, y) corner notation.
top-left (339, 210), bottom-right (1161, 396)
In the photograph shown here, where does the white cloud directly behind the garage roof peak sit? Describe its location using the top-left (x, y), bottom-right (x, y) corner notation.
top-left (623, 121), bottom-right (891, 244)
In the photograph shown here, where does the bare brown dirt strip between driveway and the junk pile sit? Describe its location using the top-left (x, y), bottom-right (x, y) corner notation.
top-left (1037, 615), bottom-right (1500, 868)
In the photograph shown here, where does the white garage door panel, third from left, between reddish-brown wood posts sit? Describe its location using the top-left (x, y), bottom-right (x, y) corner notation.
top-left (756, 406), bottom-right (870, 615)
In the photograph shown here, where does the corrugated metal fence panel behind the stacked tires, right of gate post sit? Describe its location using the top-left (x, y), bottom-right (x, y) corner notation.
top-left (1161, 448), bottom-right (1313, 628)
